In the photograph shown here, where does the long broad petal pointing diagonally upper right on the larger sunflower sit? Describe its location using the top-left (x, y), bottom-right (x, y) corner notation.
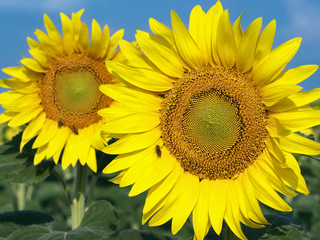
top-left (252, 38), bottom-right (301, 86)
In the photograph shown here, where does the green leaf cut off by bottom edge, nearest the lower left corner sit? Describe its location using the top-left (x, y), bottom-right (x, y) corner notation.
top-left (7, 226), bottom-right (50, 240)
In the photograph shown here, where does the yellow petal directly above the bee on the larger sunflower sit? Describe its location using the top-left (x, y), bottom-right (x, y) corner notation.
top-left (103, 128), bottom-right (161, 154)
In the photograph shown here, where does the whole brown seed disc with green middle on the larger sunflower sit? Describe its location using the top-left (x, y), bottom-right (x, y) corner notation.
top-left (161, 67), bottom-right (267, 180)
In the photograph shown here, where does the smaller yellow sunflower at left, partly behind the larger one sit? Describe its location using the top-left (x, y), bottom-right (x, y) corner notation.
top-left (0, 10), bottom-right (123, 171)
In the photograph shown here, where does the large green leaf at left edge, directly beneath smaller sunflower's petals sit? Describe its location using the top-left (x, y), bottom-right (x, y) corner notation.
top-left (0, 133), bottom-right (55, 184)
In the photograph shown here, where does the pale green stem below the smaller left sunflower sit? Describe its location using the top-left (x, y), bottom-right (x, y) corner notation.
top-left (71, 163), bottom-right (87, 229)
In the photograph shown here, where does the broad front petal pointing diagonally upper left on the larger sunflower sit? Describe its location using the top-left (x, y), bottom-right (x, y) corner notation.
top-left (136, 31), bottom-right (183, 78)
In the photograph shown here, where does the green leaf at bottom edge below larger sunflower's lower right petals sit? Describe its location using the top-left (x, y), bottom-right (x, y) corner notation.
top-left (259, 225), bottom-right (302, 240)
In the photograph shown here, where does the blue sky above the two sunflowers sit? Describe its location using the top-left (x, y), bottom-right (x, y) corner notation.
top-left (0, 0), bottom-right (320, 91)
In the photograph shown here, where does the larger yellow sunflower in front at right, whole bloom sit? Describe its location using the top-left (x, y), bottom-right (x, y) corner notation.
top-left (99, 1), bottom-right (320, 239)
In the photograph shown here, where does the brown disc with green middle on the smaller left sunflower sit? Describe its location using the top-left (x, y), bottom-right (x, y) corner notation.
top-left (40, 54), bottom-right (112, 131)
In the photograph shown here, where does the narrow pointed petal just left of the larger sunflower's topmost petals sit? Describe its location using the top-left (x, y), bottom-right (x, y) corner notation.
top-left (171, 10), bottom-right (201, 69)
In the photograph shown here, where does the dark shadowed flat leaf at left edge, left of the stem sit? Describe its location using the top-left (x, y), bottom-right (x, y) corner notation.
top-left (0, 211), bottom-right (53, 225)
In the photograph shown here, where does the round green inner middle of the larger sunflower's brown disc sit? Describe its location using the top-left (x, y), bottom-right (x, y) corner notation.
top-left (182, 93), bottom-right (240, 151)
